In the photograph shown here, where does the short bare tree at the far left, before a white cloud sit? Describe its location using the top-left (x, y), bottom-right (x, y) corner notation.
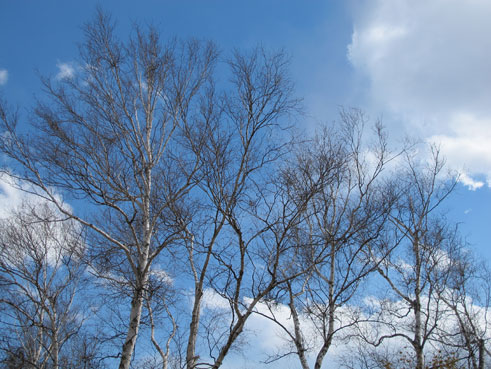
top-left (0, 204), bottom-right (87, 369)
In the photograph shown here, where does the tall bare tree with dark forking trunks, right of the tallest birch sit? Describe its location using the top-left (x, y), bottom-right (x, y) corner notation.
top-left (159, 48), bottom-right (308, 368)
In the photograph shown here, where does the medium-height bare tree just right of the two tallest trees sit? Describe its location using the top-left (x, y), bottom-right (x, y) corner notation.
top-left (256, 109), bottom-right (394, 369)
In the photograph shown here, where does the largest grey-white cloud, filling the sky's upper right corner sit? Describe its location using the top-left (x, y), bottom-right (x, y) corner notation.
top-left (348, 0), bottom-right (491, 189)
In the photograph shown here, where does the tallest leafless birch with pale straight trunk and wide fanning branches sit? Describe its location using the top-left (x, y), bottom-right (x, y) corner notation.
top-left (0, 12), bottom-right (217, 369)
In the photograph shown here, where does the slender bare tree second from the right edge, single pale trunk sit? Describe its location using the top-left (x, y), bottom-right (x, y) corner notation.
top-left (368, 147), bottom-right (456, 369)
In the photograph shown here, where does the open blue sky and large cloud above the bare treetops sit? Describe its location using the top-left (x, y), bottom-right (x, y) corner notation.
top-left (0, 0), bottom-right (491, 260)
